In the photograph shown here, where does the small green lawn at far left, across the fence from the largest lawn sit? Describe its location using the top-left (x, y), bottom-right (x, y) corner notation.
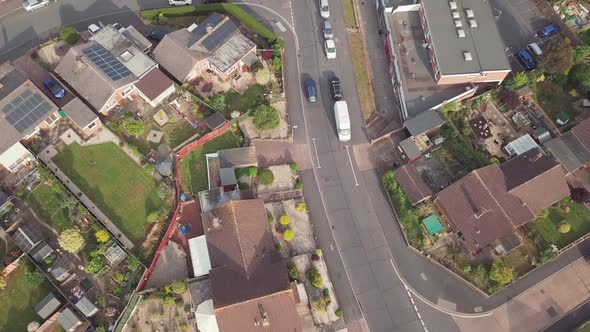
top-left (27, 184), bottom-right (73, 233)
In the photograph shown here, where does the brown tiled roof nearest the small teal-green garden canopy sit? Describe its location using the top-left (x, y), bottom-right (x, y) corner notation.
top-left (435, 166), bottom-right (513, 252)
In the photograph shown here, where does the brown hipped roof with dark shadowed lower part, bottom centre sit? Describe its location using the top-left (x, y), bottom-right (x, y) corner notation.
top-left (202, 199), bottom-right (289, 308)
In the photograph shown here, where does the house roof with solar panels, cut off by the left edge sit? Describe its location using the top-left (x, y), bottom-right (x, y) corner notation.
top-left (0, 62), bottom-right (57, 153)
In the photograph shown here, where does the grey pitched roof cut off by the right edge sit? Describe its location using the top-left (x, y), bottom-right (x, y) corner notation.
top-left (544, 131), bottom-right (590, 173)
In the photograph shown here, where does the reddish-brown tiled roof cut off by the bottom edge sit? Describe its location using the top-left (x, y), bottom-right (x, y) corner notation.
top-left (215, 289), bottom-right (302, 332)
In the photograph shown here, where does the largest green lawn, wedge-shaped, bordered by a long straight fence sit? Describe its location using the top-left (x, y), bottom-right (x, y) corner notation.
top-left (53, 143), bottom-right (163, 245)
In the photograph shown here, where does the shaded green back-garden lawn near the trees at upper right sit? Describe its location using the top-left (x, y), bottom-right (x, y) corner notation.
top-left (536, 80), bottom-right (576, 122)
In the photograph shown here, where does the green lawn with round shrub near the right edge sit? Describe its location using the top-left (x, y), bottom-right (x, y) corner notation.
top-left (529, 198), bottom-right (590, 249)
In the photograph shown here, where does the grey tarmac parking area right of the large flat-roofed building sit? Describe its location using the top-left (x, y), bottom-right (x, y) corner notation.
top-left (490, 0), bottom-right (558, 71)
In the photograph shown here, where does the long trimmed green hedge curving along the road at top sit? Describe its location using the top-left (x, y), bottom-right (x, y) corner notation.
top-left (141, 3), bottom-right (277, 44)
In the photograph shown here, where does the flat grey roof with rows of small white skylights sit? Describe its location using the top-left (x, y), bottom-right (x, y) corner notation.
top-left (422, 0), bottom-right (510, 75)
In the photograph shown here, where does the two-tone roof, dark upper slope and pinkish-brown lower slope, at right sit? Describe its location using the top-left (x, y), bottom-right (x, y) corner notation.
top-left (500, 149), bottom-right (570, 214)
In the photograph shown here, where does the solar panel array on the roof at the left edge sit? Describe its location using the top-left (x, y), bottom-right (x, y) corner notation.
top-left (2, 89), bottom-right (52, 133)
